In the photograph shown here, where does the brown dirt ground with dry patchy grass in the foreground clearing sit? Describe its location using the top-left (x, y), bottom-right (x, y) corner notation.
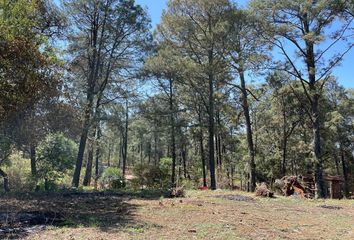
top-left (0, 191), bottom-right (354, 240)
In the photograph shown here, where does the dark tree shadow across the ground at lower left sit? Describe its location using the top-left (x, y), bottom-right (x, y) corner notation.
top-left (0, 191), bottom-right (166, 239)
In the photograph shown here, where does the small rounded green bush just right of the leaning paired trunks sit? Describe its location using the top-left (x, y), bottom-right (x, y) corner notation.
top-left (100, 167), bottom-right (125, 189)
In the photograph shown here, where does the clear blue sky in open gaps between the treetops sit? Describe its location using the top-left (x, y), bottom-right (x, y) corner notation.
top-left (135, 0), bottom-right (354, 88)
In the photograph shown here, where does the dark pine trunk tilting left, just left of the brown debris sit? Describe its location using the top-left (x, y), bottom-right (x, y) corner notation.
top-left (239, 67), bottom-right (256, 192)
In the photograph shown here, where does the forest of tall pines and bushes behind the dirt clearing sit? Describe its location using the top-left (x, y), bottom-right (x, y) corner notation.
top-left (0, 0), bottom-right (354, 239)
